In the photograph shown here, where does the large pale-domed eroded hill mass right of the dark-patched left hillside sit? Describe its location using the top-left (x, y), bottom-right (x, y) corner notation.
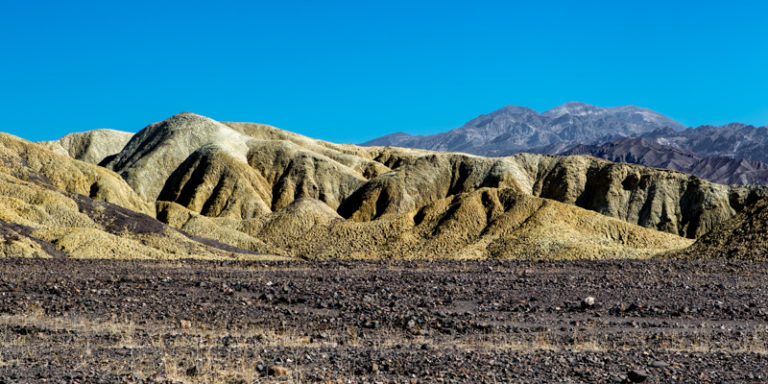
top-left (13, 113), bottom-right (762, 259)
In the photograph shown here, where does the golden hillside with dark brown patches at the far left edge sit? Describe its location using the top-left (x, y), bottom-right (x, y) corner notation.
top-left (0, 134), bottom-right (278, 259)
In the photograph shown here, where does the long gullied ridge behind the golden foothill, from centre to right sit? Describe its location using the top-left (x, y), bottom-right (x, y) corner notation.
top-left (339, 148), bottom-right (757, 238)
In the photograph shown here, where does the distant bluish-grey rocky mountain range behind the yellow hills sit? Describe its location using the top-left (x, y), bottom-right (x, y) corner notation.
top-left (363, 102), bottom-right (768, 184)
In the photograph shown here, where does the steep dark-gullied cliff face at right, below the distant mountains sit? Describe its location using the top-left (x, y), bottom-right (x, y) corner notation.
top-left (512, 154), bottom-right (764, 238)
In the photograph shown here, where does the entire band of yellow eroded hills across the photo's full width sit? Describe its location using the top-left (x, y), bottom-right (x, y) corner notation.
top-left (0, 113), bottom-right (768, 259)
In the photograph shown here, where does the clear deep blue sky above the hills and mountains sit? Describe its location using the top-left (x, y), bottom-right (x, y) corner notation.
top-left (0, 0), bottom-right (768, 143)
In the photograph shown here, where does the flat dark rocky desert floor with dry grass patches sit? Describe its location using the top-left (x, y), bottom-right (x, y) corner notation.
top-left (0, 259), bottom-right (768, 383)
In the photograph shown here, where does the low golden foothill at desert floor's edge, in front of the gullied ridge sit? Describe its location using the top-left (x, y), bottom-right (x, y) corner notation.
top-left (159, 188), bottom-right (691, 259)
